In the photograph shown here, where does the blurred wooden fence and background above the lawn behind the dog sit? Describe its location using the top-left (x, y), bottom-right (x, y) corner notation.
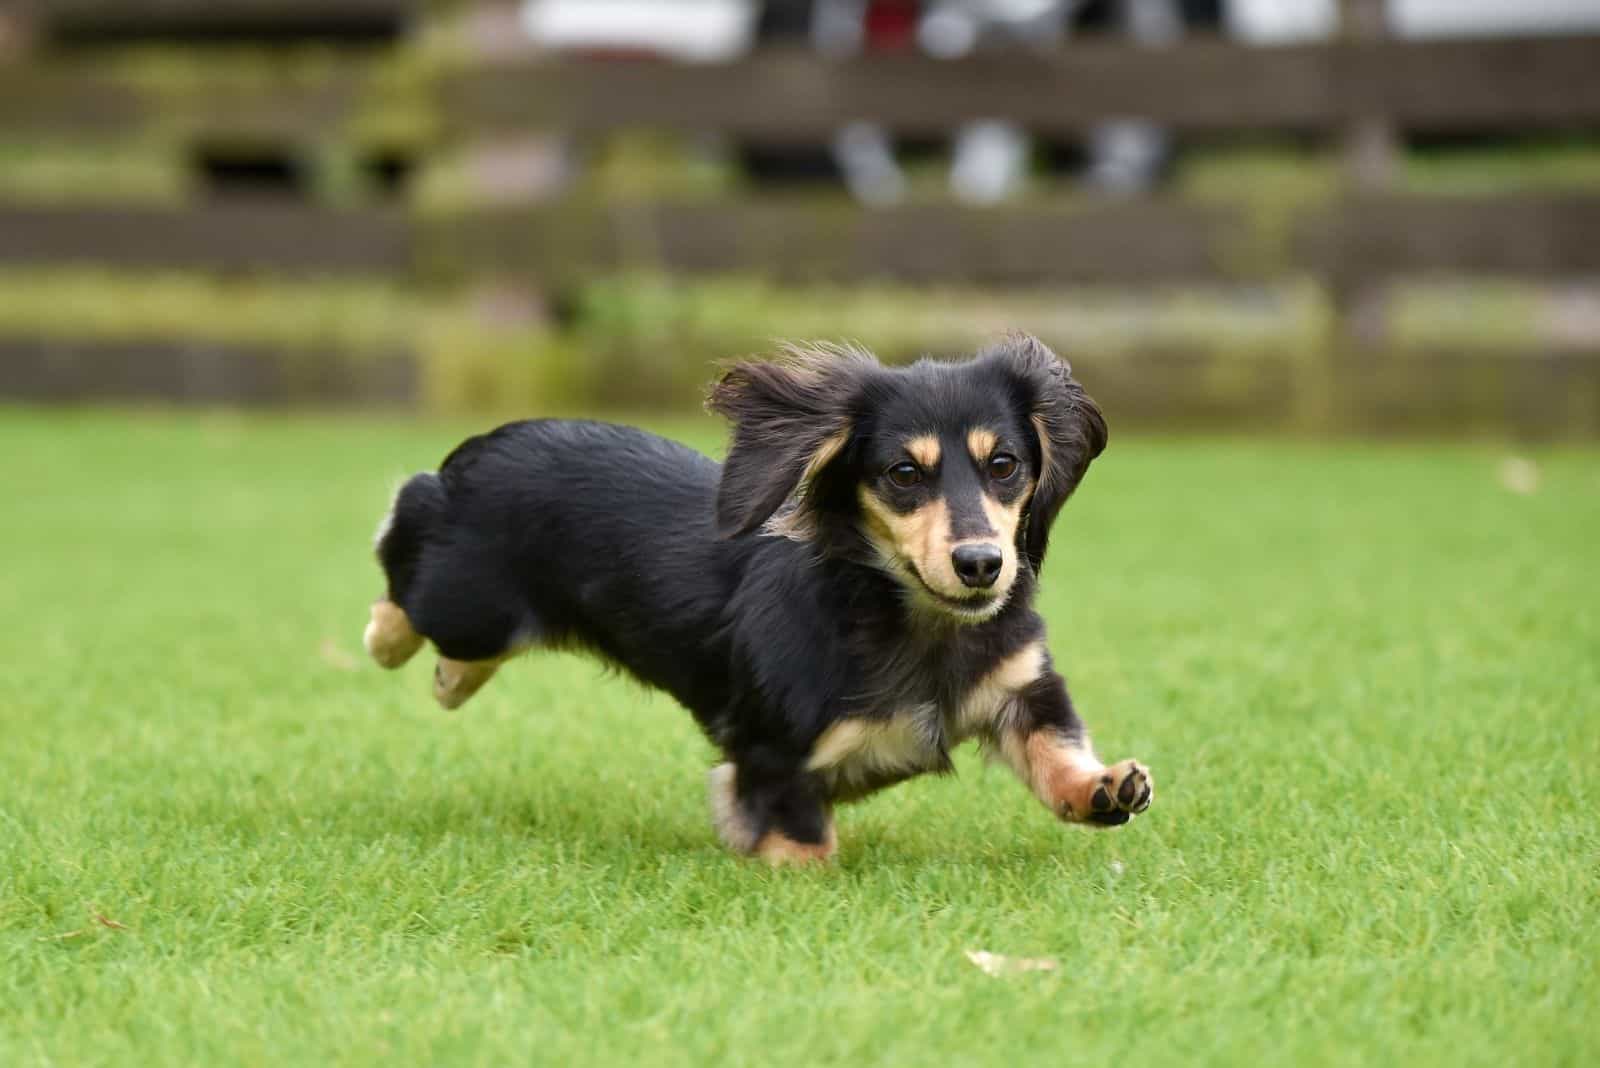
top-left (0, 0), bottom-right (1600, 438)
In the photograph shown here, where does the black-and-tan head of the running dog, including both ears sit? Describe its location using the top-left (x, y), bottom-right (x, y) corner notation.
top-left (709, 334), bottom-right (1106, 622)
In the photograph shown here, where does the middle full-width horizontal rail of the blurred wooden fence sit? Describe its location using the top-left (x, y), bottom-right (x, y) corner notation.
top-left (12, 193), bottom-right (1580, 286)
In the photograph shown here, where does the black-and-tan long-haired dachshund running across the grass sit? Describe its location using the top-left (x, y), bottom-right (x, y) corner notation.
top-left (366, 336), bottom-right (1154, 863)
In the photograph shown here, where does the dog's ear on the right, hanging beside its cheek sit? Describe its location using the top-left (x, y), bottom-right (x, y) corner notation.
top-left (987, 334), bottom-right (1106, 574)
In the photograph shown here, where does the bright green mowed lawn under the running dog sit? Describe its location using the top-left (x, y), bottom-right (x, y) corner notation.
top-left (0, 409), bottom-right (1600, 1066)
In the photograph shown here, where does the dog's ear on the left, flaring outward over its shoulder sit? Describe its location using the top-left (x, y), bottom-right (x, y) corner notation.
top-left (706, 347), bottom-right (877, 537)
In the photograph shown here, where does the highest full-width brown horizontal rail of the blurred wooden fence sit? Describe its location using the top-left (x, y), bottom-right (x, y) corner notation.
top-left (0, 35), bottom-right (1600, 141)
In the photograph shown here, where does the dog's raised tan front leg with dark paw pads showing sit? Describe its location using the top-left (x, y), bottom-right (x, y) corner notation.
top-left (994, 671), bottom-right (1155, 827)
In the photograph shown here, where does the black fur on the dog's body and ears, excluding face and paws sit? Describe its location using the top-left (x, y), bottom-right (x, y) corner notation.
top-left (378, 336), bottom-right (1107, 843)
